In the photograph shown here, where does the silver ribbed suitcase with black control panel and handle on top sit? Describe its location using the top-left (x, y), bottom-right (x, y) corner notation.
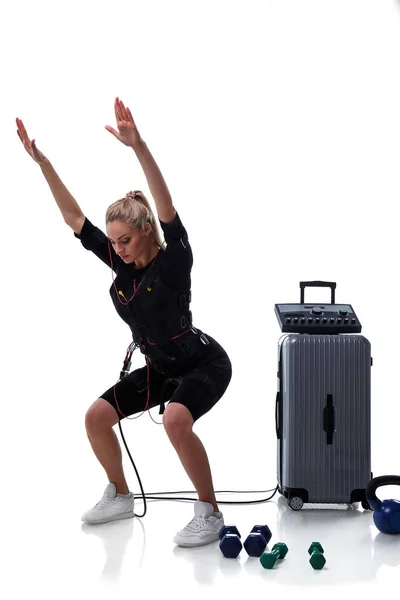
top-left (275, 281), bottom-right (372, 510)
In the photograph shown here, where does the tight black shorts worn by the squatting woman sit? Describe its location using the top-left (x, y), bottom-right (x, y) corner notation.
top-left (100, 340), bottom-right (232, 421)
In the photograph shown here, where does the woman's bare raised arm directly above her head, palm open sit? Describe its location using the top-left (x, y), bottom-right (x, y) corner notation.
top-left (106, 98), bottom-right (176, 223)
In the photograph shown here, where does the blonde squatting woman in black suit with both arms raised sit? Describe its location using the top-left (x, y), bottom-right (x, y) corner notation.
top-left (17, 98), bottom-right (232, 547)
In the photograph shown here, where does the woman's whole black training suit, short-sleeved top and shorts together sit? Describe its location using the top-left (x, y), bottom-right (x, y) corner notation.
top-left (74, 213), bottom-right (232, 421)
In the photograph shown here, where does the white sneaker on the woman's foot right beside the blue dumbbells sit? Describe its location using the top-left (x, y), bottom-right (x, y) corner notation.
top-left (174, 500), bottom-right (224, 548)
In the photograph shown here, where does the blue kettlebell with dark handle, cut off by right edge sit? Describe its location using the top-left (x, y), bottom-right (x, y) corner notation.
top-left (366, 475), bottom-right (400, 534)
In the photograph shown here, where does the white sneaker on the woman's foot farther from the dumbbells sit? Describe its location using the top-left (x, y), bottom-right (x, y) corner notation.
top-left (82, 483), bottom-right (134, 525)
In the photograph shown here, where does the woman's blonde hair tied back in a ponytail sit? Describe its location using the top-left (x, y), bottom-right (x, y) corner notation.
top-left (106, 190), bottom-right (165, 250)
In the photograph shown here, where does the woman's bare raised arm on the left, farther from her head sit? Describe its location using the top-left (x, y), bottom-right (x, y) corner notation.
top-left (16, 119), bottom-right (85, 235)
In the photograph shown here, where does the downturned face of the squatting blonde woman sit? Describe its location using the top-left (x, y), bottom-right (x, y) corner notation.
top-left (107, 221), bottom-right (151, 263)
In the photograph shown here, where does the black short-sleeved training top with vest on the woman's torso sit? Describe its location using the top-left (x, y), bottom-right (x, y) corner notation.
top-left (74, 213), bottom-right (212, 374)
